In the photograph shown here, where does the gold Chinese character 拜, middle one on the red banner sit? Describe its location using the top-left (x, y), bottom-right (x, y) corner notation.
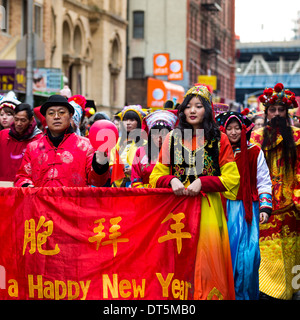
top-left (89, 217), bottom-right (129, 257)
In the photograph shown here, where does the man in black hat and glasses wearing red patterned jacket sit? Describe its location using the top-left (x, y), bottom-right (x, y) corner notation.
top-left (14, 95), bottom-right (110, 187)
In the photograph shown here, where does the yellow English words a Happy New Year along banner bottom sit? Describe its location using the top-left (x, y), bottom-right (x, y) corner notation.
top-left (8, 273), bottom-right (192, 300)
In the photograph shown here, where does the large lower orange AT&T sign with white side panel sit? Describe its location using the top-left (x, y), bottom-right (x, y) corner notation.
top-left (147, 78), bottom-right (184, 108)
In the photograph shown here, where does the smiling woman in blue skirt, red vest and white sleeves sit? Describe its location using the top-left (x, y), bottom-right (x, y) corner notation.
top-left (216, 111), bottom-right (272, 300)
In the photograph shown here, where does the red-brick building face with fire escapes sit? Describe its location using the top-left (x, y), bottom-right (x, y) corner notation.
top-left (187, 0), bottom-right (235, 101)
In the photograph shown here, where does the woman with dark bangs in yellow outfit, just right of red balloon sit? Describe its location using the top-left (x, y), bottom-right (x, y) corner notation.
top-left (109, 105), bottom-right (147, 187)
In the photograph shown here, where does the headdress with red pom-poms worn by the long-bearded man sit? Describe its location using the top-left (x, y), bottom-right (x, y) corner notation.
top-left (259, 83), bottom-right (298, 109)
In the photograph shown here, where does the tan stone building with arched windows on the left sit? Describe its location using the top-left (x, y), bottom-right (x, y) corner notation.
top-left (0, 0), bottom-right (127, 114)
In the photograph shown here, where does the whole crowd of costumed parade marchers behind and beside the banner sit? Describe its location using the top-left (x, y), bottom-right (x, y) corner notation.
top-left (0, 83), bottom-right (300, 300)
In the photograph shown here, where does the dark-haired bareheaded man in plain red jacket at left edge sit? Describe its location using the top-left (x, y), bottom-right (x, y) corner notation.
top-left (0, 103), bottom-right (42, 181)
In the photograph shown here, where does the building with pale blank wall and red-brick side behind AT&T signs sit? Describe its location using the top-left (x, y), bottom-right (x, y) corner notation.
top-left (126, 0), bottom-right (235, 106)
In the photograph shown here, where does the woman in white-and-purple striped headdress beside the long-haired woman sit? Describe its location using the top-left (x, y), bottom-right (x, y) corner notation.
top-left (131, 110), bottom-right (178, 188)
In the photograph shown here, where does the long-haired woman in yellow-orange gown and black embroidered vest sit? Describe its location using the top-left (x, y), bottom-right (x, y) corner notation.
top-left (150, 85), bottom-right (240, 300)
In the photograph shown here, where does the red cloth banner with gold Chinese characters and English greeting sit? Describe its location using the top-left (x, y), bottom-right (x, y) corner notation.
top-left (0, 188), bottom-right (201, 300)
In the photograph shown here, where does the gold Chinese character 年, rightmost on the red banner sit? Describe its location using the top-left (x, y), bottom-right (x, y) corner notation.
top-left (158, 212), bottom-right (192, 254)
